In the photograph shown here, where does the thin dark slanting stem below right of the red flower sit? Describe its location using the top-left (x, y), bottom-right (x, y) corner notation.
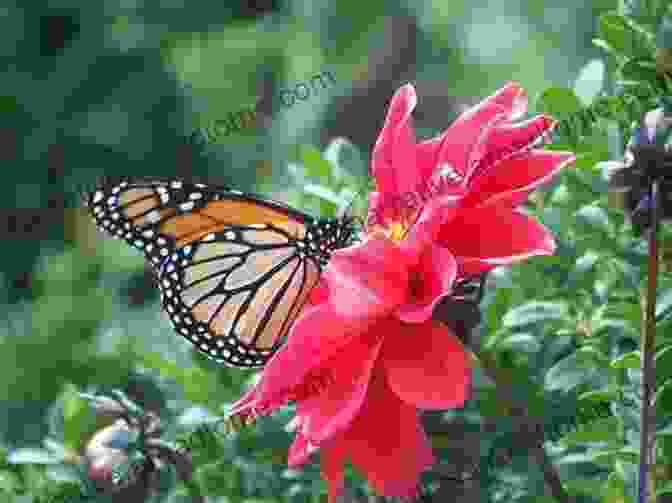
top-left (474, 349), bottom-right (573, 503)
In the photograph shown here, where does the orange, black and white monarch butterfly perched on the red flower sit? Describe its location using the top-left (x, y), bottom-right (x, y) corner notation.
top-left (82, 178), bottom-right (355, 368)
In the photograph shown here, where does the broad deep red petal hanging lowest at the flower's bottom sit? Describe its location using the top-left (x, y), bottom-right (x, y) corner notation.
top-left (334, 372), bottom-right (434, 496)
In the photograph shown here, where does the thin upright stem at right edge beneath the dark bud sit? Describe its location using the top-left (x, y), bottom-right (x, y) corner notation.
top-left (638, 180), bottom-right (659, 503)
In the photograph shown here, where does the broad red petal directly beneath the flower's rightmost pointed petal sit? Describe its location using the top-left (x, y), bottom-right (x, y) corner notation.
top-left (439, 205), bottom-right (555, 274)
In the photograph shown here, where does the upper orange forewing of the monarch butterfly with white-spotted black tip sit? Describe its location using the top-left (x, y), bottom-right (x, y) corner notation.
top-left (85, 178), bottom-right (308, 269)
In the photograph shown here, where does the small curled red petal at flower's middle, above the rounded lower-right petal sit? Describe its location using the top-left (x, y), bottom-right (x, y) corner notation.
top-left (397, 242), bottom-right (457, 323)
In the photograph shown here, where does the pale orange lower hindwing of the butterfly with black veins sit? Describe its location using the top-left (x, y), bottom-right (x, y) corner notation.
top-left (159, 223), bottom-right (320, 367)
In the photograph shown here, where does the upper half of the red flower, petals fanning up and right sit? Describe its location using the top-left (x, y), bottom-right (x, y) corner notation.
top-left (369, 82), bottom-right (574, 278)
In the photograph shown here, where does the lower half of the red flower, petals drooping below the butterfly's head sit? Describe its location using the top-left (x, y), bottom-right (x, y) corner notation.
top-left (233, 236), bottom-right (470, 501)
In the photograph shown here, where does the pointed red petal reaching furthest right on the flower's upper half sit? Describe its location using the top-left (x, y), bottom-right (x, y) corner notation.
top-left (460, 150), bottom-right (575, 207)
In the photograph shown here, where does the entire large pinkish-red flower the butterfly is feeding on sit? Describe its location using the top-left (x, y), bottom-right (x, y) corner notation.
top-left (232, 84), bottom-right (572, 501)
